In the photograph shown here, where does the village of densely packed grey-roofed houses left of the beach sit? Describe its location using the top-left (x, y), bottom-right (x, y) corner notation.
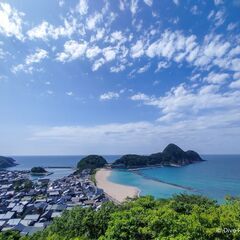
top-left (0, 169), bottom-right (108, 235)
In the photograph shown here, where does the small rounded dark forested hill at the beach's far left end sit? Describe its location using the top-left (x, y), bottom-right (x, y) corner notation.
top-left (77, 155), bottom-right (107, 170)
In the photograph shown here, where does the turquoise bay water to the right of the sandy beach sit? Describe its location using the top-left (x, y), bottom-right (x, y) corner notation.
top-left (109, 155), bottom-right (240, 202)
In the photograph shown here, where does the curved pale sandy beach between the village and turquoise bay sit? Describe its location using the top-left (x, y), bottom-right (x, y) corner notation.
top-left (95, 169), bottom-right (140, 203)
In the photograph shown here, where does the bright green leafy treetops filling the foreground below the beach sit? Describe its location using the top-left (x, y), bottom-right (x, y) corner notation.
top-left (0, 195), bottom-right (240, 240)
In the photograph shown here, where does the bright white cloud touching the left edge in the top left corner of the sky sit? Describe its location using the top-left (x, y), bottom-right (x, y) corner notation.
top-left (0, 3), bottom-right (24, 40)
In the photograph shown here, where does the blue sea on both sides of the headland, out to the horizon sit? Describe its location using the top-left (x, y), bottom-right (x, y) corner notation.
top-left (10, 155), bottom-right (240, 203)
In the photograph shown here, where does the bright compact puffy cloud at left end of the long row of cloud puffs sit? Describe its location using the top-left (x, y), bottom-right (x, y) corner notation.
top-left (56, 40), bottom-right (87, 62)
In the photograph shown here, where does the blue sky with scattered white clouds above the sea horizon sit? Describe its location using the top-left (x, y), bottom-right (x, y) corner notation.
top-left (0, 0), bottom-right (240, 155)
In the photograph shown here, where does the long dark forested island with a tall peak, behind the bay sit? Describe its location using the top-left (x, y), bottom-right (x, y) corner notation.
top-left (112, 143), bottom-right (202, 168)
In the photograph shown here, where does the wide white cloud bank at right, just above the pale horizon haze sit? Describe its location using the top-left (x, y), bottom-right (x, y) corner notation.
top-left (131, 84), bottom-right (240, 124)
